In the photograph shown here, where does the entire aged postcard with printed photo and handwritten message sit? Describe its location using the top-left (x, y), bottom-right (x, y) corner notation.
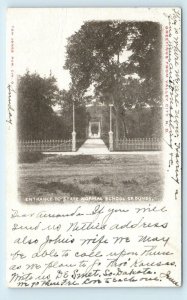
top-left (6, 8), bottom-right (181, 288)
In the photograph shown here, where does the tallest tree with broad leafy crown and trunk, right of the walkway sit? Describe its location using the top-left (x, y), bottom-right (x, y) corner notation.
top-left (65, 21), bottom-right (161, 139)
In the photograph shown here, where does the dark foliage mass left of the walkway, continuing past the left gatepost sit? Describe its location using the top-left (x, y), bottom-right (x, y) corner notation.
top-left (17, 72), bottom-right (87, 140)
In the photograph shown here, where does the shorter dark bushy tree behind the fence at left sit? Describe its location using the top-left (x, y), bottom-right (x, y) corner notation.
top-left (17, 72), bottom-right (65, 140)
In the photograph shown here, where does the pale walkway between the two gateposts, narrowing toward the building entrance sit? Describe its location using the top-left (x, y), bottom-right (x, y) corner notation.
top-left (77, 139), bottom-right (110, 154)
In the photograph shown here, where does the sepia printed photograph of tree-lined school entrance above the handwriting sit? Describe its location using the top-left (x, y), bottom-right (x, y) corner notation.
top-left (15, 13), bottom-right (164, 203)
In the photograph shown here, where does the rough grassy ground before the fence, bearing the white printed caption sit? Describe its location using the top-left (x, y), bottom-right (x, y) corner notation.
top-left (18, 153), bottom-right (164, 202)
